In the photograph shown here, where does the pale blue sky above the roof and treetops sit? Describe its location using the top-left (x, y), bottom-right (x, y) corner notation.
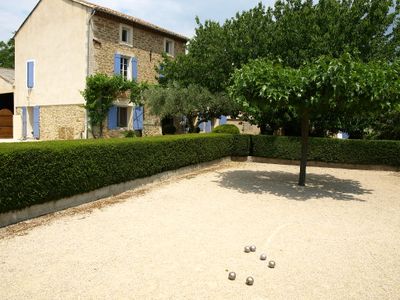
top-left (0, 0), bottom-right (275, 41)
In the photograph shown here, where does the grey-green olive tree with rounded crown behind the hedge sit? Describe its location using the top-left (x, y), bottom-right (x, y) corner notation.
top-left (144, 83), bottom-right (235, 133)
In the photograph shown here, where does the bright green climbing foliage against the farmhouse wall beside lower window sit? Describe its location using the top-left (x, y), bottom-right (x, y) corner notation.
top-left (82, 74), bottom-right (142, 138)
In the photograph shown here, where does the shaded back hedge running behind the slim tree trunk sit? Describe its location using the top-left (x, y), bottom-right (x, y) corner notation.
top-left (251, 135), bottom-right (400, 167)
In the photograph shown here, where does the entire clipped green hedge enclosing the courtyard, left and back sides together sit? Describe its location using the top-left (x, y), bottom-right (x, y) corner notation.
top-left (0, 134), bottom-right (400, 213)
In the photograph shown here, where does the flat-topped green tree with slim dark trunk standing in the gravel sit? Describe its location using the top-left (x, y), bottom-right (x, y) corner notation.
top-left (230, 54), bottom-right (400, 186)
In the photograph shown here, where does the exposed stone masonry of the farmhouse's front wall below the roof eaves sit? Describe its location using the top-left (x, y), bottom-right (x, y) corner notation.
top-left (92, 15), bottom-right (185, 137)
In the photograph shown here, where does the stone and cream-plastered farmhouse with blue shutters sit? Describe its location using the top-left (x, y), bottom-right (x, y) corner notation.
top-left (13, 0), bottom-right (188, 140)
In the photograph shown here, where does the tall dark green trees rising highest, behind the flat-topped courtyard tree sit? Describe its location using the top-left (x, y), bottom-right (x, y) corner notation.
top-left (162, 0), bottom-right (400, 135)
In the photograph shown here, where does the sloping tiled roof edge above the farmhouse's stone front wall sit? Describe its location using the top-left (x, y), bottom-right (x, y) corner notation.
top-left (72, 0), bottom-right (189, 42)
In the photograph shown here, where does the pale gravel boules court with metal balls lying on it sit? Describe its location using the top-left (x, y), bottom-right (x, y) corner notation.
top-left (0, 162), bottom-right (400, 299)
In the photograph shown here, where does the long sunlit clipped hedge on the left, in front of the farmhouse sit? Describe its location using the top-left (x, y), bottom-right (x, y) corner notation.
top-left (0, 134), bottom-right (234, 213)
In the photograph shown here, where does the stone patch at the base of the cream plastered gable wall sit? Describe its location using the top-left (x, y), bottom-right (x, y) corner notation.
top-left (40, 105), bottom-right (85, 140)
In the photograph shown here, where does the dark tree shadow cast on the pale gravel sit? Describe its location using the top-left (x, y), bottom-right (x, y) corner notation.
top-left (216, 170), bottom-right (372, 202)
